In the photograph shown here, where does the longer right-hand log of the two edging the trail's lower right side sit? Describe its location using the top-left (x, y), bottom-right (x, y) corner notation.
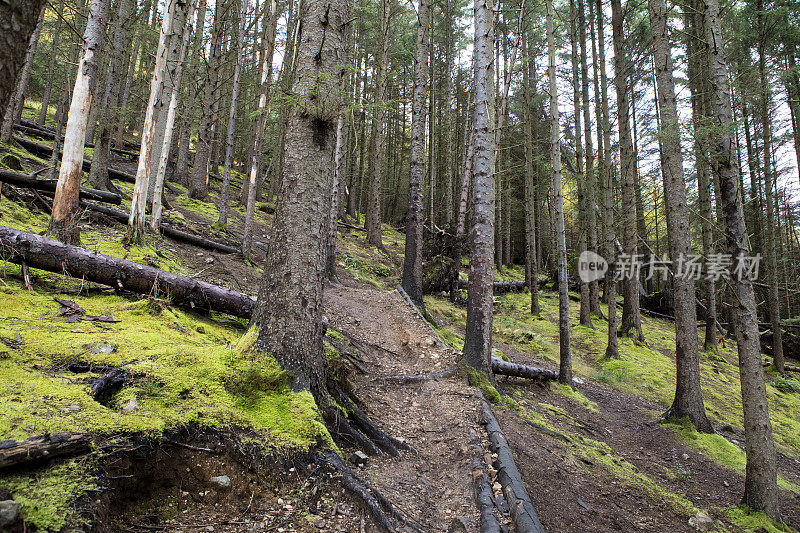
top-left (482, 400), bottom-right (544, 533)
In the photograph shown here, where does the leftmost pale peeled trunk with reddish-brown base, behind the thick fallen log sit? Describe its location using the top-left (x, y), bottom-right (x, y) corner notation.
top-left (50, 0), bottom-right (110, 244)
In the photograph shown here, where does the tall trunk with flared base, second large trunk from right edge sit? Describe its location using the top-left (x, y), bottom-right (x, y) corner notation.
top-left (648, 0), bottom-right (714, 432)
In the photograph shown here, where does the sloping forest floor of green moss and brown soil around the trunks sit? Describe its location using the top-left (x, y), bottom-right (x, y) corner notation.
top-left (0, 110), bottom-right (800, 532)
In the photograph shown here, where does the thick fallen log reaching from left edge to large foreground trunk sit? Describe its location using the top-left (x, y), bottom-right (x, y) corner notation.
top-left (0, 226), bottom-right (256, 318)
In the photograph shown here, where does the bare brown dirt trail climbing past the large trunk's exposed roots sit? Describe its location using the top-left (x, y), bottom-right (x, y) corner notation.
top-left (325, 285), bottom-right (486, 532)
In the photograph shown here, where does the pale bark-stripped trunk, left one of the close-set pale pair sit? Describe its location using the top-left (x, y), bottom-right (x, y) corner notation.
top-left (128, 0), bottom-right (188, 242)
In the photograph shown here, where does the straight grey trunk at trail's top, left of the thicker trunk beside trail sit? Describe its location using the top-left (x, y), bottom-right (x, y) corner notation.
top-left (364, 0), bottom-right (392, 248)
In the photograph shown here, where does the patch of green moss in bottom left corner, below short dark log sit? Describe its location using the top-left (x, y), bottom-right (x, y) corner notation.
top-left (0, 459), bottom-right (97, 531)
